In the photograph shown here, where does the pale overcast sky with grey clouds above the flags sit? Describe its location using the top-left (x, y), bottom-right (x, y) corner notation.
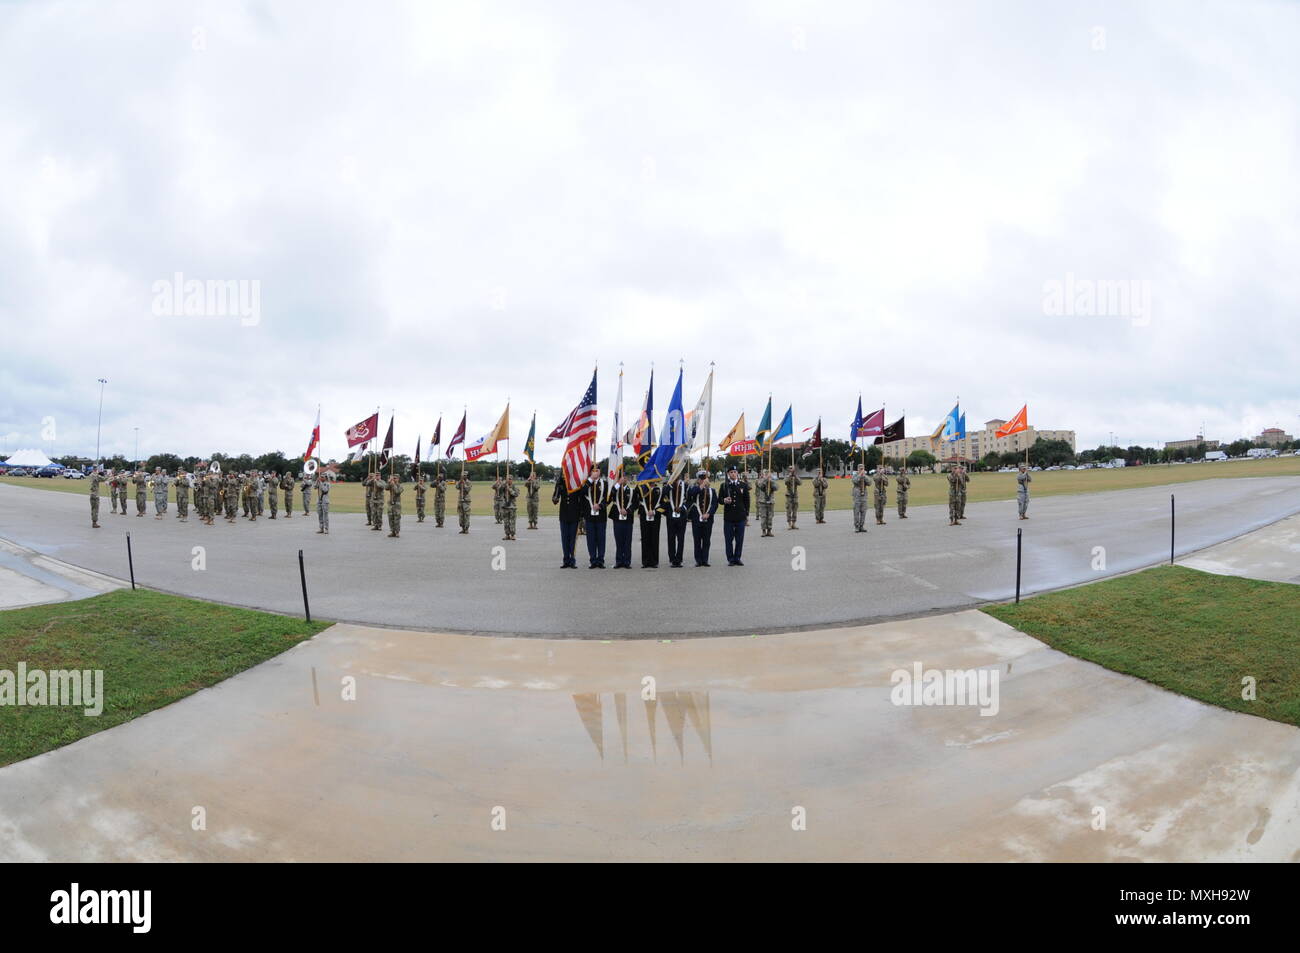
top-left (0, 0), bottom-right (1300, 462)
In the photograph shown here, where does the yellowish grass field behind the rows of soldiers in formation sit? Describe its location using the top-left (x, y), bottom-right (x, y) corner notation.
top-left (0, 456), bottom-right (1300, 519)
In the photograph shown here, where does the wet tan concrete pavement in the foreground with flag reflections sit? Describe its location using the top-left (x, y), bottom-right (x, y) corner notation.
top-left (0, 612), bottom-right (1300, 862)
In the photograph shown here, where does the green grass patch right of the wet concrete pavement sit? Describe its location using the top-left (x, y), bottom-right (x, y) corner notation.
top-left (984, 566), bottom-right (1300, 725)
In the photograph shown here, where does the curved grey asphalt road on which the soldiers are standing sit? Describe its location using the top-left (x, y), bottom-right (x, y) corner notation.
top-left (0, 477), bottom-right (1300, 638)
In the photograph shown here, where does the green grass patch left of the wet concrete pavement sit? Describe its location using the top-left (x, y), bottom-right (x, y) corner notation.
top-left (0, 589), bottom-right (329, 766)
